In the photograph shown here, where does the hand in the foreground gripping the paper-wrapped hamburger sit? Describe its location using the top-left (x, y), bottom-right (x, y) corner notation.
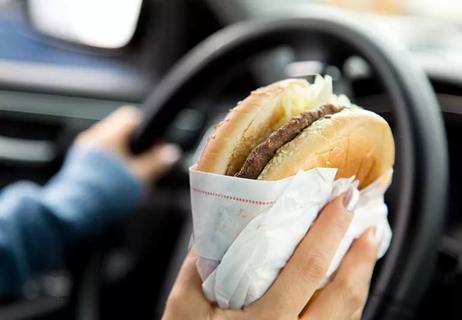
top-left (163, 196), bottom-right (378, 320)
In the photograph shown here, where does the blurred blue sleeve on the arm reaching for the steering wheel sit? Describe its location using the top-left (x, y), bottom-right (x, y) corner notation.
top-left (0, 146), bottom-right (141, 296)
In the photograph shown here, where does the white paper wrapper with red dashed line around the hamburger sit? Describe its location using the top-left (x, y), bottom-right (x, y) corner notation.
top-left (190, 167), bottom-right (392, 309)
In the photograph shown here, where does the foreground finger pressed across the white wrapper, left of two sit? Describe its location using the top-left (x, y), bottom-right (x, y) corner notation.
top-left (259, 195), bottom-right (352, 316)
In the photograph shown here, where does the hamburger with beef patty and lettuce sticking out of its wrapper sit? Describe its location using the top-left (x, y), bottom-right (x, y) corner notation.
top-left (196, 76), bottom-right (395, 189)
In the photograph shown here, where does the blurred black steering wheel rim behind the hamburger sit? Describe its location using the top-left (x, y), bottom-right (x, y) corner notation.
top-left (78, 13), bottom-right (448, 319)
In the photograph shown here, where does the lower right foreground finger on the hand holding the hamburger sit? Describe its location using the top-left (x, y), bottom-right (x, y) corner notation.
top-left (301, 229), bottom-right (378, 320)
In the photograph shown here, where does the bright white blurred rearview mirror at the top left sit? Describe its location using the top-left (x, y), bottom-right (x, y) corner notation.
top-left (28, 0), bottom-right (143, 49)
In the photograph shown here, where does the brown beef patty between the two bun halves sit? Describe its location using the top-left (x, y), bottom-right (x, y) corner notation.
top-left (234, 104), bottom-right (343, 179)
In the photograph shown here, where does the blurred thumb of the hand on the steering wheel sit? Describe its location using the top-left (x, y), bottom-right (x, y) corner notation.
top-left (133, 143), bottom-right (181, 181)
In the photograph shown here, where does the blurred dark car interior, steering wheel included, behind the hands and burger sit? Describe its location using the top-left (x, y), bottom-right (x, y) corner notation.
top-left (0, 0), bottom-right (462, 320)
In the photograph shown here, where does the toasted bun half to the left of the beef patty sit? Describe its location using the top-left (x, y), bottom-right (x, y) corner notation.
top-left (197, 79), bottom-right (308, 175)
